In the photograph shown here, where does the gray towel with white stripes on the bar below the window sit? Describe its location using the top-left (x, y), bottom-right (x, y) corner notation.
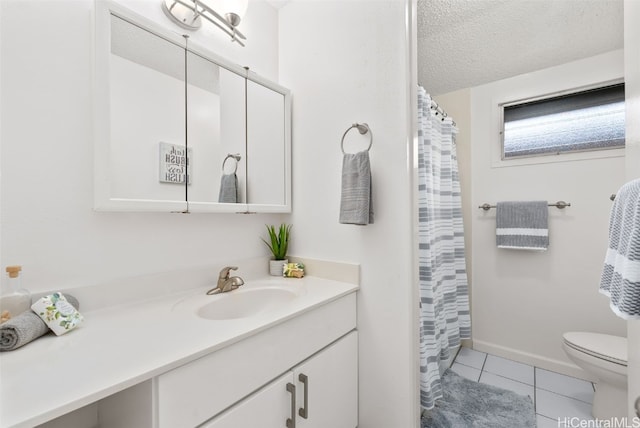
top-left (496, 201), bottom-right (549, 251)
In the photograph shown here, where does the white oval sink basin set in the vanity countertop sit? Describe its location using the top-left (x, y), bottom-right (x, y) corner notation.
top-left (196, 287), bottom-right (298, 320)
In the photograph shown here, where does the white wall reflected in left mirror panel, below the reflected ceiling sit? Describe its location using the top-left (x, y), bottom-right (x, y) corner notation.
top-left (109, 53), bottom-right (185, 201)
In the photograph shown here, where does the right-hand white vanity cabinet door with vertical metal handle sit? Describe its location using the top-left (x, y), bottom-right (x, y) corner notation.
top-left (294, 331), bottom-right (358, 428)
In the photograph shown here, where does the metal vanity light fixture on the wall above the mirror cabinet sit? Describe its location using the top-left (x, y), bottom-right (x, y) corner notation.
top-left (162, 0), bottom-right (248, 46)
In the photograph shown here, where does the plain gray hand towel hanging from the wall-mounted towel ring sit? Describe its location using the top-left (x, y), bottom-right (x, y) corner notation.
top-left (340, 151), bottom-right (373, 225)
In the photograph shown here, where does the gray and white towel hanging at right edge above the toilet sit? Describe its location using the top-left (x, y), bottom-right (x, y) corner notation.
top-left (600, 179), bottom-right (640, 320)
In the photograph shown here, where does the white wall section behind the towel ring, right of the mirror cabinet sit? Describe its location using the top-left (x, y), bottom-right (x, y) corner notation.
top-left (280, 0), bottom-right (419, 428)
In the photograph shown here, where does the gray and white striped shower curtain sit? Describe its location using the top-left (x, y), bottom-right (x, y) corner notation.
top-left (418, 87), bottom-right (471, 409)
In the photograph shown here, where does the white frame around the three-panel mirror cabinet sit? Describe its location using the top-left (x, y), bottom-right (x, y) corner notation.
top-left (94, 0), bottom-right (291, 213)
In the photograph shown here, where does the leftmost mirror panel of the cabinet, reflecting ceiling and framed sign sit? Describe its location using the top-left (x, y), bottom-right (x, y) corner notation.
top-left (109, 16), bottom-right (188, 201)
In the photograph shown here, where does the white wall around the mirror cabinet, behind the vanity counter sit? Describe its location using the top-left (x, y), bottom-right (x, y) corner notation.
top-left (0, 0), bottom-right (284, 291)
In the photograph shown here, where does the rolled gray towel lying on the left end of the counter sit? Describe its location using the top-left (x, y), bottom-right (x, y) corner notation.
top-left (0, 294), bottom-right (80, 351)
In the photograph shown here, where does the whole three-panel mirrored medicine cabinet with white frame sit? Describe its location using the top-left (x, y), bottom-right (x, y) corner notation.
top-left (94, 0), bottom-right (291, 212)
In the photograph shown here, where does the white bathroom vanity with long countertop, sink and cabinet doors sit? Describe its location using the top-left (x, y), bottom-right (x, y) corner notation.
top-left (0, 267), bottom-right (358, 428)
